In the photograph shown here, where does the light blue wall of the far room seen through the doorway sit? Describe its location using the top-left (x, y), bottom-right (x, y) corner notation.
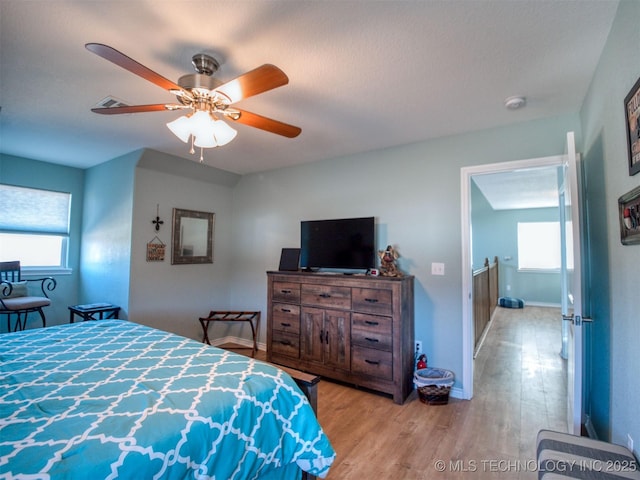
top-left (471, 182), bottom-right (561, 306)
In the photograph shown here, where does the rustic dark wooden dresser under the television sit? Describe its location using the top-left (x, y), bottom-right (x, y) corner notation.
top-left (267, 272), bottom-right (414, 404)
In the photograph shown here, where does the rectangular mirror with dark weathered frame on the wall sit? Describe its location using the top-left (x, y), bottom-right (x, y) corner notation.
top-left (171, 208), bottom-right (215, 265)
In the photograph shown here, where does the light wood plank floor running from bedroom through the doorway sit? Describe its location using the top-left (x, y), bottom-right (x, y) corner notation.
top-left (245, 307), bottom-right (566, 480)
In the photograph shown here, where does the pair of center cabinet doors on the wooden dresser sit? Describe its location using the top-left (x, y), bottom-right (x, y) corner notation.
top-left (300, 307), bottom-right (351, 370)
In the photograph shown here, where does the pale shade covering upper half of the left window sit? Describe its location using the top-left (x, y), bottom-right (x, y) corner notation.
top-left (0, 184), bottom-right (71, 235)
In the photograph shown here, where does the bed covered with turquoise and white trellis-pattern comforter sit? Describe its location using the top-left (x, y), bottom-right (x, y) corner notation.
top-left (0, 320), bottom-right (335, 480)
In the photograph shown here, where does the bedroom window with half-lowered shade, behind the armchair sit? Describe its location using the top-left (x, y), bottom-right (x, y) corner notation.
top-left (0, 184), bottom-right (71, 270)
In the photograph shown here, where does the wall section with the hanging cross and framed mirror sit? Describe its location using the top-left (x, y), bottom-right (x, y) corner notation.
top-left (129, 150), bottom-right (240, 340)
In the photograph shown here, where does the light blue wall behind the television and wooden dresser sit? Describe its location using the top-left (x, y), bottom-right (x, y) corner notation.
top-left (230, 110), bottom-right (580, 386)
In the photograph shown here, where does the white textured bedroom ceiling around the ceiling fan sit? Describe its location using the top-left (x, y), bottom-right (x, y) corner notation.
top-left (0, 0), bottom-right (617, 179)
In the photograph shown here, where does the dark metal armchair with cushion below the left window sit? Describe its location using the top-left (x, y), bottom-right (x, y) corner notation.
top-left (0, 261), bottom-right (57, 332)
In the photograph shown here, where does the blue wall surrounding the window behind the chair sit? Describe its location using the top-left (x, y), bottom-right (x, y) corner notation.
top-left (0, 154), bottom-right (84, 332)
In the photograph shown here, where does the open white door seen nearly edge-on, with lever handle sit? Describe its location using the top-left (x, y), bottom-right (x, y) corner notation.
top-left (560, 132), bottom-right (583, 435)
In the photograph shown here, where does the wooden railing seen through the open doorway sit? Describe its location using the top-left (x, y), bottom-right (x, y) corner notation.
top-left (473, 257), bottom-right (498, 347)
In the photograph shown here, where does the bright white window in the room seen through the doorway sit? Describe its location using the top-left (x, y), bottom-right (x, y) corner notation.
top-left (518, 222), bottom-right (573, 271)
